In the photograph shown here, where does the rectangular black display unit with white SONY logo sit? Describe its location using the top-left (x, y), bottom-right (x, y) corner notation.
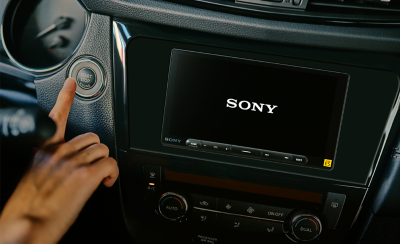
top-left (161, 49), bottom-right (349, 170)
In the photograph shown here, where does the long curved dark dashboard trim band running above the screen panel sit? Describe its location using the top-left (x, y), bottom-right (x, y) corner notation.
top-left (81, 0), bottom-right (400, 54)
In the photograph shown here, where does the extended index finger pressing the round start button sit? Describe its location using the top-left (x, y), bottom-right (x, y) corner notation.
top-left (46, 78), bottom-right (76, 144)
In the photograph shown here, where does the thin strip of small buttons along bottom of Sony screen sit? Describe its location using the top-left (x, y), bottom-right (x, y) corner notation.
top-left (186, 139), bottom-right (308, 164)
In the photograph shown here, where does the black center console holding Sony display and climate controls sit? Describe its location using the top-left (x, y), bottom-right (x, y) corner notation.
top-left (114, 22), bottom-right (399, 243)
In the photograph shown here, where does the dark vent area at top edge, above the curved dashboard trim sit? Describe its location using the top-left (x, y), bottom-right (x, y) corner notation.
top-left (168, 0), bottom-right (400, 27)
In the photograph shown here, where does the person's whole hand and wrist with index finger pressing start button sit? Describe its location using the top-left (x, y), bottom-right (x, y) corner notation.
top-left (0, 78), bottom-right (119, 244)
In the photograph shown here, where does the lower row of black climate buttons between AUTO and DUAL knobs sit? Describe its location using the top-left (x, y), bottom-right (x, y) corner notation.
top-left (190, 209), bottom-right (283, 234)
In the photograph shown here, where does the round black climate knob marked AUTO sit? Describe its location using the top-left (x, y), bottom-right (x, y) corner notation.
top-left (158, 192), bottom-right (188, 221)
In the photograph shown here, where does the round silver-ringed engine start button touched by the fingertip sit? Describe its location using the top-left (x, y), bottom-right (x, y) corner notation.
top-left (68, 57), bottom-right (106, 98)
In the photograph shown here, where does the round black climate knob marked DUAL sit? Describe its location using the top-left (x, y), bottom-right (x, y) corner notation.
top-left (290, 211), bottom-right (322, 241)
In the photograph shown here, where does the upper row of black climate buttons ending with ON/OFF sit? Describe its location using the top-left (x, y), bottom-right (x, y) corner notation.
top-left (192, 194), bottom-right (292, 221)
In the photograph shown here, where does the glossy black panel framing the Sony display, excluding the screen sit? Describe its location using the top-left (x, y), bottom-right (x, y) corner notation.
top-left (126, 37), bottom-right (399, 185)
